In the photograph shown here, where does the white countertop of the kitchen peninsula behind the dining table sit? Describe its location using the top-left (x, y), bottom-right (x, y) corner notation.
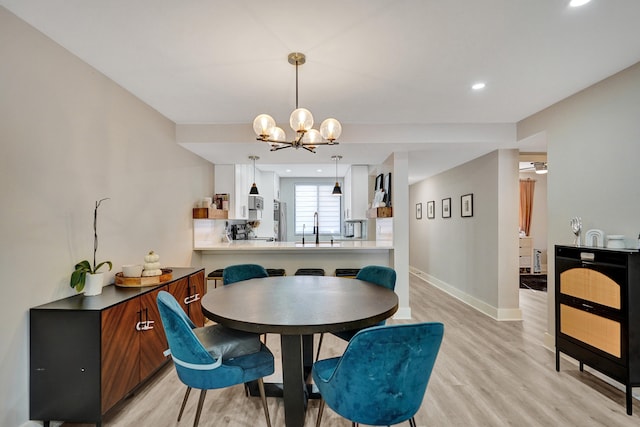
top-left (193, 239), bottom-right (393, 252)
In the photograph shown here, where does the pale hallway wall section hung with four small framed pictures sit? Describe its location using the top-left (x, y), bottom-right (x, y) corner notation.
top-left (409, 150), bottom-right (521, 320)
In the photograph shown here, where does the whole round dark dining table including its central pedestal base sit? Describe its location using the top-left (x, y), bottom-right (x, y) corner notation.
top-left (202, 276), bottom-right (398, 427)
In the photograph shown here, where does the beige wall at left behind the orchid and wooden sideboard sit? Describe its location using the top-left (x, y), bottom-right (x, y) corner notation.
top-left (0, 8), bottom-right (213, 426)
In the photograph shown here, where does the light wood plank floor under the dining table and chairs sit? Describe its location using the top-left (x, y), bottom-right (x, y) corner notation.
top-left (65, 276), bottom-right (640, 427)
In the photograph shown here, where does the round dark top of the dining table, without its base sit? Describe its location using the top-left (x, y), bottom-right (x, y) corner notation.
top-left (202, 276), bottom-right (398, 335)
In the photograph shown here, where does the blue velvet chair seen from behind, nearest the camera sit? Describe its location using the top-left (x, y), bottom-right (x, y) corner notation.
top-left (312, 322), bottom-right (444, 427)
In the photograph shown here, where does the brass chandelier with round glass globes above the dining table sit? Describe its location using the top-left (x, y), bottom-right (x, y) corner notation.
top-left (253, 52), bottom-right (342, 153)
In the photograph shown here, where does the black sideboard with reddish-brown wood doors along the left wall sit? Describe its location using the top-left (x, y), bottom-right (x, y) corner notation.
top-left (29, 268), bottom-right (205, 426)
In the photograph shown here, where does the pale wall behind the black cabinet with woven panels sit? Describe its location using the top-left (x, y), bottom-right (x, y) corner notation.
top-left (518, 63), bottom-right (640, 346)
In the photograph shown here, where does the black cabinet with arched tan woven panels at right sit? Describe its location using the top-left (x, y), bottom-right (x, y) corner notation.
top-left (555, 246), bottom-right (640, 415)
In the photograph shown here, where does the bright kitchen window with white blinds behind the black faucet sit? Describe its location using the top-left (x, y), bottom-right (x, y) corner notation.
top-left (294, 183), bottom-right (342, 236)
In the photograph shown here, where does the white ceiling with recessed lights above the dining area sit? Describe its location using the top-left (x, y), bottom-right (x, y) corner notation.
top-left (5, 0), bottom-right (640, 182)
